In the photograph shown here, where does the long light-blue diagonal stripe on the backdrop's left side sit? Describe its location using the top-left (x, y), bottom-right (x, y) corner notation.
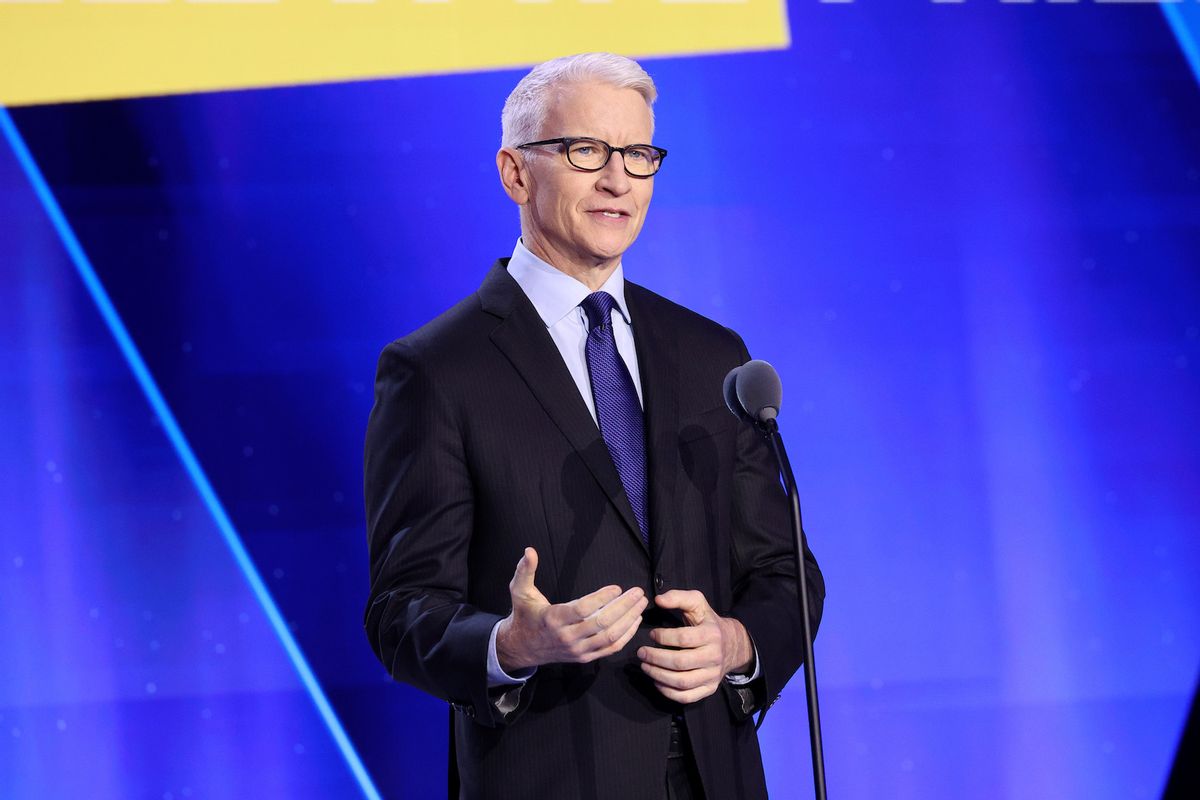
top-left (0, 106), bottom-right (382, 800)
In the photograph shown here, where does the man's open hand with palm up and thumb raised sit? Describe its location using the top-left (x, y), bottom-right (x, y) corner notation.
top-left (496, 547), bottom-right (649, 673)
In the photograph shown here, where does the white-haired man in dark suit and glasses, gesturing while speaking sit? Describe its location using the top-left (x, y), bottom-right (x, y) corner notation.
top-left (365, 54), bottom-right (824, 800)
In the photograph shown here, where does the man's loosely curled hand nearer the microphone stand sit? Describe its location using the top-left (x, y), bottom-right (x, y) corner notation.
top-left (637, 589), bottom-right (754, 703)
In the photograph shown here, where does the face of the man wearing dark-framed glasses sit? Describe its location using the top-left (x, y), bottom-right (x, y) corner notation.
top-left (521, 83), bottom-right (654, 272)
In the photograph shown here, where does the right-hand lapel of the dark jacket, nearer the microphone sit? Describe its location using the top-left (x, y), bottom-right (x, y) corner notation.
top-left (625, 281), bottom-right (679, 564)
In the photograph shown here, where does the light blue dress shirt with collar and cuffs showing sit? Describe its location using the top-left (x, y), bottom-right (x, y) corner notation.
top-left (487, 239), bottom-right (758, 695)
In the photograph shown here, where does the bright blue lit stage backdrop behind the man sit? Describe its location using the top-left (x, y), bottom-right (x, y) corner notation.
top-left (0, 2), bottom-right (1200, 800)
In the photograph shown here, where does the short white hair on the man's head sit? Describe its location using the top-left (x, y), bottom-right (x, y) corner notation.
top-left (500, 53), bottom-right (659, 148)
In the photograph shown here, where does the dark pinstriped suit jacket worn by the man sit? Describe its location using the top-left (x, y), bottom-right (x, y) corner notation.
top-left (365, 259), bottom-right (824, 800)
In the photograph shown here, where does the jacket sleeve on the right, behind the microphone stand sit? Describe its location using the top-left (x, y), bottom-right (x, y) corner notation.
top-left (722, 339), bottom-right (826, 724)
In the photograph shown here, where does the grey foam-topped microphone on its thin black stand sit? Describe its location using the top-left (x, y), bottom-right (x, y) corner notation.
top-left (721, 359), bottom-right (826, 800)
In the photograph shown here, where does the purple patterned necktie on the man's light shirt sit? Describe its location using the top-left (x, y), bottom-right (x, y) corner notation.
top-left (580, 291), bottom-right (650, 546)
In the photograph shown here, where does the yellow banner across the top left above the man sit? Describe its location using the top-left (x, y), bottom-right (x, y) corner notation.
top-left (0, 0), bottom-right (788, 106)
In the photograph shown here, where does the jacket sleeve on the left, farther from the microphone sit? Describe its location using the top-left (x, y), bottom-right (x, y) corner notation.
top-left (364, 342), bottom-right (532, 727)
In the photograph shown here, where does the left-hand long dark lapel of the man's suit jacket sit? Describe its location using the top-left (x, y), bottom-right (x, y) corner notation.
top-left (479, 258), bottom-right (642, 551)
